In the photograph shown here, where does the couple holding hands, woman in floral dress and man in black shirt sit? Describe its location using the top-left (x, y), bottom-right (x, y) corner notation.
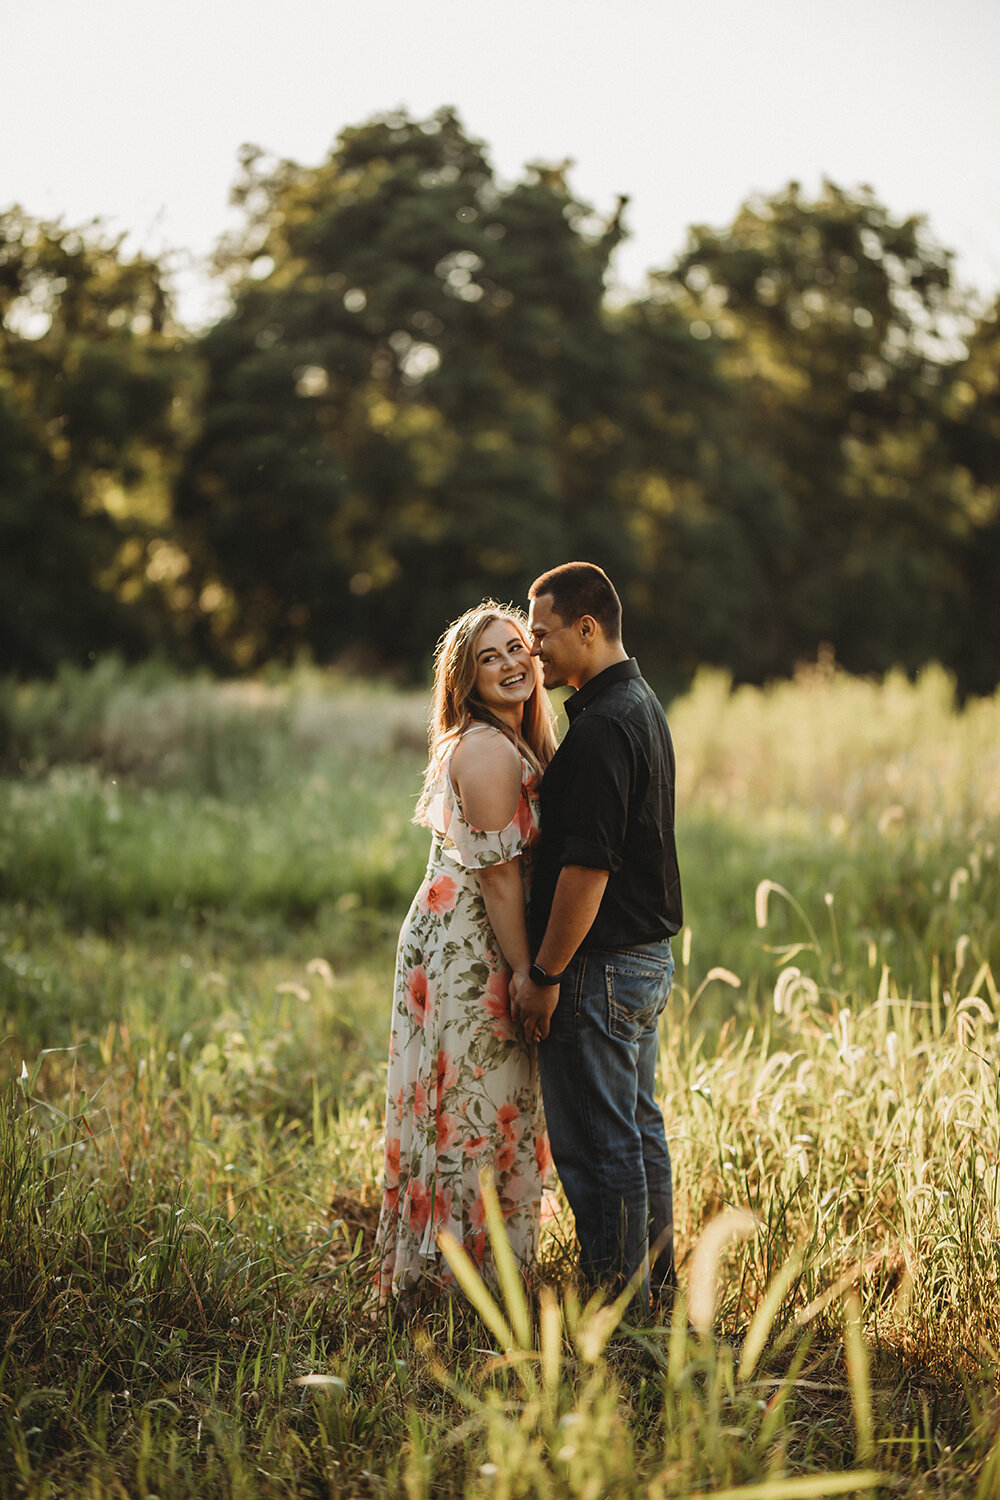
top-left (376, 563), bottom-right (681, 1308)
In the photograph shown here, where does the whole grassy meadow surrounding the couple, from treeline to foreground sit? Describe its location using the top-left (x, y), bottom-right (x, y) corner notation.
top-left (0, 662), bottom-right (1000, 1500)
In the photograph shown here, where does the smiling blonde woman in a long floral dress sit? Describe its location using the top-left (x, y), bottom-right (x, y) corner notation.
top-left (376, 602), bottom-right (556, 1304)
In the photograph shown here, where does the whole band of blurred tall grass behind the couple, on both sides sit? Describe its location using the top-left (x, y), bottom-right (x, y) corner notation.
top-left (0, 663), bottom-right (1000, 1002)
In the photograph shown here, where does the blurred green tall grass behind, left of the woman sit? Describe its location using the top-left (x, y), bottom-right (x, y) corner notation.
top-left (0, 663), bottom-right (426, 936)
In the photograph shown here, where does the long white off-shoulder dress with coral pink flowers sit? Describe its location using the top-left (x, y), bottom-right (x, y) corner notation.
top-left (376, 731), bottom-right (552, 1304)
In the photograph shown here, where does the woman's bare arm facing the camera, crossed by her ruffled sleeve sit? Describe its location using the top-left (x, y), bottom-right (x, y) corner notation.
top-left (451, 732), bottom-right (531, 975)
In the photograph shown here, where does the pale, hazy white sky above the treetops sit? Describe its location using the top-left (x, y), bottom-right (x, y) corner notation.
top-left (0, 0), bottom-right (1000, 324)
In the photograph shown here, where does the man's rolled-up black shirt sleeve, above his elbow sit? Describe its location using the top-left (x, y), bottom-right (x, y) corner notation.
top-left (562, 716), bottom-right (631, 873)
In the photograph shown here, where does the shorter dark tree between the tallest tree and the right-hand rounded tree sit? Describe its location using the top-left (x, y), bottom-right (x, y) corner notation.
top-left (605, 287), bottom-right (775, 690)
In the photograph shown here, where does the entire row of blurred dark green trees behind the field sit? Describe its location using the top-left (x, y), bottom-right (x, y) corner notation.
top-left (0, 110), bottom-right (1000, 695)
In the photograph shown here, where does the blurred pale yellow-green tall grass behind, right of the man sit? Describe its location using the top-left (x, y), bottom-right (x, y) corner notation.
top-left (672, 668), bottom-right (1000, 995)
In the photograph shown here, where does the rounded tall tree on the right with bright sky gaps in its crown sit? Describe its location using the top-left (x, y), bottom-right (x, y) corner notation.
top-left (660, 183), bottom-right (970, 687)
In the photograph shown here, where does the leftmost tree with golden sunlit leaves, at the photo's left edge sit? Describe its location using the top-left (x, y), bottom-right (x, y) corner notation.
top-left (0, 209), bottom-right (187, 674)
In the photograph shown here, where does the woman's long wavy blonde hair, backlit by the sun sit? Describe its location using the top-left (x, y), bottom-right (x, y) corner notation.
top-left (414, 599), bottom-right (556, 824)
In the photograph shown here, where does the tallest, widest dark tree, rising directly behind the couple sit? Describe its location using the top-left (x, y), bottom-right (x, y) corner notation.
top-left (178, 111), bottom-right (644, 668)
